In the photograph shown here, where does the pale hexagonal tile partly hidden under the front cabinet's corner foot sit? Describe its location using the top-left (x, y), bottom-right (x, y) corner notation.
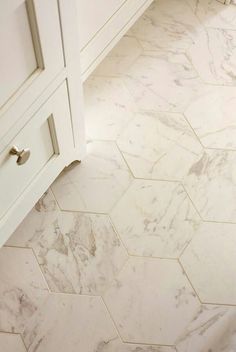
top-left (52, 142), bottom-right (132, 213)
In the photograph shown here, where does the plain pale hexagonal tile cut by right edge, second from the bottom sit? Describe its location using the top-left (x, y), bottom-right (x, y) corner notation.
top-left (181, 223), bottom-right (236, 304)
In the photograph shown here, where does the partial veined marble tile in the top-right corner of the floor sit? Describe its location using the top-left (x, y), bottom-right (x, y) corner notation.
top-left (187, 0), bottom-right (236, 29)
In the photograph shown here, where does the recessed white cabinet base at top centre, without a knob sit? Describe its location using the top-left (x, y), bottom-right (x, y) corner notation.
top-left (77, 0), bottom-right (153, 80)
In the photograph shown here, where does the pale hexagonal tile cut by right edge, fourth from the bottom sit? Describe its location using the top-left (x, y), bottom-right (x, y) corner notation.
top-left (185, 87), bottom-right (236, 149)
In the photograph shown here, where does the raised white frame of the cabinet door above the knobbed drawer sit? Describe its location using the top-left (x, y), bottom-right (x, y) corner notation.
top-left (0, 0), bottom-right (64, 139)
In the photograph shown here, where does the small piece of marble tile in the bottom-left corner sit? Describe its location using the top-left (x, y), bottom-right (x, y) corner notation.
top-left (0, 332), bottom-right (26, 352)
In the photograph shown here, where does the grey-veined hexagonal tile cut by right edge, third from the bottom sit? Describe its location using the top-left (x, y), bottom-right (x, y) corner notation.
top-left (184, 149), bottom-right (236, 222)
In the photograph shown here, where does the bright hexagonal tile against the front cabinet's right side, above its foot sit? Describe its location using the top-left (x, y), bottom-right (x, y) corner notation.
top-left (84, 77), bottom-right (135, 140)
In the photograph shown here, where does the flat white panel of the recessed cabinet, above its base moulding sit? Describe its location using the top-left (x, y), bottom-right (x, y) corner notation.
top-left (78, 0), bottom-right (126, 50)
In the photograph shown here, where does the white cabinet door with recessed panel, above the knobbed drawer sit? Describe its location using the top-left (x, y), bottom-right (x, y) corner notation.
top-left (0, 0), bottom-right (64, 143)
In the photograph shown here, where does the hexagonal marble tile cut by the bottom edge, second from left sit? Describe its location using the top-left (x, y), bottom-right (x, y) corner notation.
top-left (23, 294), bottom-right (117, 352)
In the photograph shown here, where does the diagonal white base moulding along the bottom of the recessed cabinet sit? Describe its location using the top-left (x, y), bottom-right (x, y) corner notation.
top-left (77, 0), bottom-right (153, 81)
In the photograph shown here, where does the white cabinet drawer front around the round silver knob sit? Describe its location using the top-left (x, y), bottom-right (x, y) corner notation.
top-left (0, 83), bottom-right (73, 219)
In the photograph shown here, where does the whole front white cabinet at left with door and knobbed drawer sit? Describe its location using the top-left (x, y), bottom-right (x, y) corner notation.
top-left (0, 0), bottom-right (85, 245)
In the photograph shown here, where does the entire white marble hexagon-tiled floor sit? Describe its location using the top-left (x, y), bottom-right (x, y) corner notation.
top-left (0, 0), bottom-right (236, 352)
